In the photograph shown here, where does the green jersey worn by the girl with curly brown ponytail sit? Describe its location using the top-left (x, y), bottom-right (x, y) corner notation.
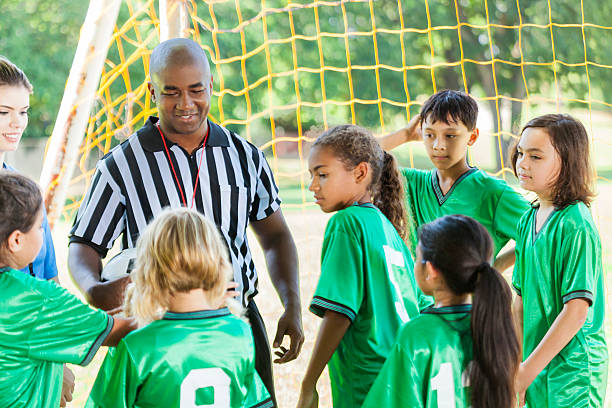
top-left (310, 204), bottom-right (433, 408)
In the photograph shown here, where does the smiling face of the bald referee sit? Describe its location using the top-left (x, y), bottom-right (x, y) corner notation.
top-left (149, 62), bottom-right (212, 147)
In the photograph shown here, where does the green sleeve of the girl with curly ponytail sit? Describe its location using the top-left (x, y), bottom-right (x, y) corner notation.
top-left (310, 230), bottom-right (364, 322)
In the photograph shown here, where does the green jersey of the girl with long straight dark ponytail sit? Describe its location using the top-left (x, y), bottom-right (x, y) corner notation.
top-left (363, 305), bottom-right (472, 408)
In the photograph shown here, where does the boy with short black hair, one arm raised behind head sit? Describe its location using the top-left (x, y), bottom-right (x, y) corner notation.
top-left (379, 90), bottom-right (529, 271)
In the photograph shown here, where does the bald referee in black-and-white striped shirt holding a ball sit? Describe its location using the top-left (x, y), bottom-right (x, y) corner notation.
top-left (68, 38), bottom-right (304, 399)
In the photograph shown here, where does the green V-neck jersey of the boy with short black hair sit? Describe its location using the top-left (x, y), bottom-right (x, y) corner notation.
top-left (402, 168), bottom-right (529, 258)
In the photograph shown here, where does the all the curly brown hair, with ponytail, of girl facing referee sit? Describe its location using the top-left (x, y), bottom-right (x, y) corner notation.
top-left (313, 125), bottom-right (408, 243)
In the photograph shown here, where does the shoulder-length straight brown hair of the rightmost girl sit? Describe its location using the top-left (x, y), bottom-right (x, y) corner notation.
top-left (510, 114), bottom-right (595, 209)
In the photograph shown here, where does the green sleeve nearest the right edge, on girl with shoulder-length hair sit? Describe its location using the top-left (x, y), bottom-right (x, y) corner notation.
top-left (557, 229), bottom-right (600, 305)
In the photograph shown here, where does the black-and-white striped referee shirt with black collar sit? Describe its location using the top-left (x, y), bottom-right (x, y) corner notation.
top-left (70, 117), bottom-right (281, 306)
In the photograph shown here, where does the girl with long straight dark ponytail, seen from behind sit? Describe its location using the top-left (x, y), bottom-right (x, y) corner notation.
top-left (363, 215), bottom-right (520, 408)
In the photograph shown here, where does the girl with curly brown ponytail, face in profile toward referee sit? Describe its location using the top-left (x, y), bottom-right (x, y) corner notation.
top-left (298, 125), bottom-right (431, 408)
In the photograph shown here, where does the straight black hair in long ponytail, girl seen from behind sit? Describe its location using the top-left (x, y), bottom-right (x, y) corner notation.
top-left (419, 215), bottom-right (520, 408)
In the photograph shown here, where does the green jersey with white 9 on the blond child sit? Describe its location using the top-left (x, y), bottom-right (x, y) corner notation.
top-left (86, 308), bottom-right (273, 408)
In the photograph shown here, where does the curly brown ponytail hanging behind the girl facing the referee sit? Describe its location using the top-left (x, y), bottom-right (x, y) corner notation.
top-left (372, 151), bottom-right (408, 243)
